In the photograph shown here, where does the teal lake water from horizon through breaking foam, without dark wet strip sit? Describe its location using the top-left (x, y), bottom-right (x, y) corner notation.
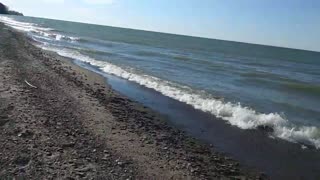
top-left (0, 16), bottom-right (320, 148)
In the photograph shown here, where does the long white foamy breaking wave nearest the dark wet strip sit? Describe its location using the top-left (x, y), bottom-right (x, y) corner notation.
top-left (39, 48), bottom-right (320, 149)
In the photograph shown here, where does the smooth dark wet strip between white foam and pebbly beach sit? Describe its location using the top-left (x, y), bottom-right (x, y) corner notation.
top-left (74, 60), bottom-right (320, 180)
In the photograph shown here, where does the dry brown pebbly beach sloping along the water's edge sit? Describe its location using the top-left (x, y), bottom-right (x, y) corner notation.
top-left (0, 23), bottom-right (268, 179)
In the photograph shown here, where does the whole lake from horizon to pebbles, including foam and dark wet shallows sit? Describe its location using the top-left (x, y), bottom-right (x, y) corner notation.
top-left (0, 16), bottom-right (320, 178)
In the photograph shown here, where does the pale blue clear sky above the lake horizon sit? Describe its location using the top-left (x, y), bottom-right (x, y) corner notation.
top-left (0, 0), bottom-right (320, 51)
